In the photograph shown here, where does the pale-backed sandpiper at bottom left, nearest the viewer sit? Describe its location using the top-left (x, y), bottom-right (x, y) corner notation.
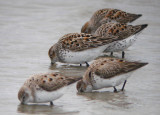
top-left (18, 73), bottom-right (81, 105)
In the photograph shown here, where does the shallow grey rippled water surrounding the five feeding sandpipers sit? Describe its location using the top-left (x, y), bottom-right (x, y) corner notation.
top-left (0, 0), bottom-right (160, 115)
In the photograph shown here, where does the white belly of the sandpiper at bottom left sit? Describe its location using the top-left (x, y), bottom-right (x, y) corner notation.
top-left (35, 88), bottom-right (64, 103)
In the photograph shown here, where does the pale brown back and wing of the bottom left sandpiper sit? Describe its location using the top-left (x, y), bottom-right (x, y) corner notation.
top-left (24, 73), bottom-right (80, 91)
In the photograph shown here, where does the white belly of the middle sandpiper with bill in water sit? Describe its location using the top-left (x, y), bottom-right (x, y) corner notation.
top-left (64, 44), bottom-right (109, 64)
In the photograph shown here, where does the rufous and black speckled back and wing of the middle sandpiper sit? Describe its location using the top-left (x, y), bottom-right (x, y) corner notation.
top-left (58, 33), bottom-right (120, 51)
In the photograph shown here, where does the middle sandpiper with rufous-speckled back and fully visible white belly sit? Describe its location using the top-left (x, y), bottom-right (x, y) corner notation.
top-left (48, 33), bottom-right (129, 66)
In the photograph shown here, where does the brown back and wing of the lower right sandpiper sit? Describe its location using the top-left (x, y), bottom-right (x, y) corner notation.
top-left (84, 57), bottom-right (148, 79)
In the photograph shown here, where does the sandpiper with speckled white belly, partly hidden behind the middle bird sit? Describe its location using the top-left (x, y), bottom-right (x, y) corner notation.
top-left (94, 23), bottom-right (148, 58)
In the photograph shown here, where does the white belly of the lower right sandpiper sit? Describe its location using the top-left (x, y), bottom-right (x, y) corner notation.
top-left (92, 72), bottom-right (132, 90)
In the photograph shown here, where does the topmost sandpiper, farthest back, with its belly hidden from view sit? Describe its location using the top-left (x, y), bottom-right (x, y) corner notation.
top-left (81, 8), bottom-right (142, 34)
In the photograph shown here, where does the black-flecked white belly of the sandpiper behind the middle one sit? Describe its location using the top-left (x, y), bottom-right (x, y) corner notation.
top-left (105, 35), bottom-right (137, 52)
